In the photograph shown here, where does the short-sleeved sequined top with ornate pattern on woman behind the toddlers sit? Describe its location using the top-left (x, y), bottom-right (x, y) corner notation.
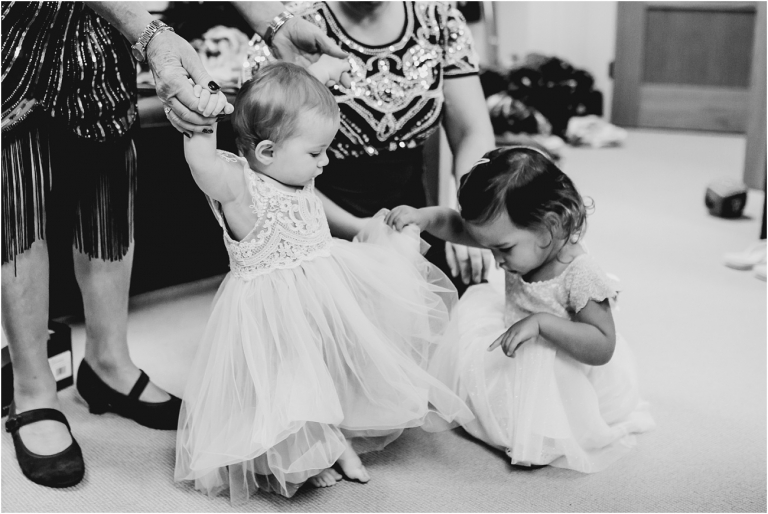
top-left (249, 2), bottom-right (478, 159)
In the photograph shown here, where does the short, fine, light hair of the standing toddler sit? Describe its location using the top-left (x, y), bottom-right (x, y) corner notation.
top-left (232, 61), bottom-right (339, 155)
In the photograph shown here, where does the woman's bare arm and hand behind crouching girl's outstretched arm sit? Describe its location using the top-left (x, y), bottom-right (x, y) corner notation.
top-left (443, 75), bottom-right (495, 284)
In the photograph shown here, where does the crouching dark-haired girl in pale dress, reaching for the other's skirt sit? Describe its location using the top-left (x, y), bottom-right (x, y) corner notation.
top-left (387, 147), bottom-right (654, 472)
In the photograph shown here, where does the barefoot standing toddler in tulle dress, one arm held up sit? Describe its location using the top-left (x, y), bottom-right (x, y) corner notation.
top-left (175, 62), bottom-right (471, 500)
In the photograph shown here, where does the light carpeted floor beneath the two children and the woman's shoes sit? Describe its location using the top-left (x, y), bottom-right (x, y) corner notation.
top-left (0, 131), bottom-right (766, 512)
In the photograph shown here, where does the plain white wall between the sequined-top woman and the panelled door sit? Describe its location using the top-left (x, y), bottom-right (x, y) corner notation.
top-left (480, 1), bottom-right (618, 119)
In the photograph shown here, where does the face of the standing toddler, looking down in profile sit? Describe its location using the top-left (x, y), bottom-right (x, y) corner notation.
top-left (267, 113), bottom-right (339, 186)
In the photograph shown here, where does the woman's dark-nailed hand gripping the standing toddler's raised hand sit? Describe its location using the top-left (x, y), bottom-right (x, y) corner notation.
top-left (147, 30), bottom-right (234, 133)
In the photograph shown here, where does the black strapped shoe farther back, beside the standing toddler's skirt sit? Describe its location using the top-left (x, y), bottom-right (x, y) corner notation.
top-left (77, 359), bottom-right (181, 430)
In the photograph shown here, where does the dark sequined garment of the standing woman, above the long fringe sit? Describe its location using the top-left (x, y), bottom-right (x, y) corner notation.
top-left (2, 2), bottom-right (138, 141)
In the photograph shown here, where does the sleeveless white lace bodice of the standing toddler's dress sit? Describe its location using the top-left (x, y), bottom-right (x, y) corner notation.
top-left (208, 151), bottom-right (332, 279)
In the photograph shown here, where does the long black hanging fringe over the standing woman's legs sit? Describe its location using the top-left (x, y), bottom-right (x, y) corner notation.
top-left (2, 118), bottom-right (138, 271)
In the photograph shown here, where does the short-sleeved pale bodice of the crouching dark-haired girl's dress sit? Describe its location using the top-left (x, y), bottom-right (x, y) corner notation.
top-left (504, 254), bottom-right (619, 326)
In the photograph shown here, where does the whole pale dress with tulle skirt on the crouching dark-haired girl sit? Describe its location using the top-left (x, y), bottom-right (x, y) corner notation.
top-left (433, 254), bottom-right (654, 473)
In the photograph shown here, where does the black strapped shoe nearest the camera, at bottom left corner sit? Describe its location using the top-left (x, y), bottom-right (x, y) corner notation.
top-left (5, 403), bottom-right (85, 488)
